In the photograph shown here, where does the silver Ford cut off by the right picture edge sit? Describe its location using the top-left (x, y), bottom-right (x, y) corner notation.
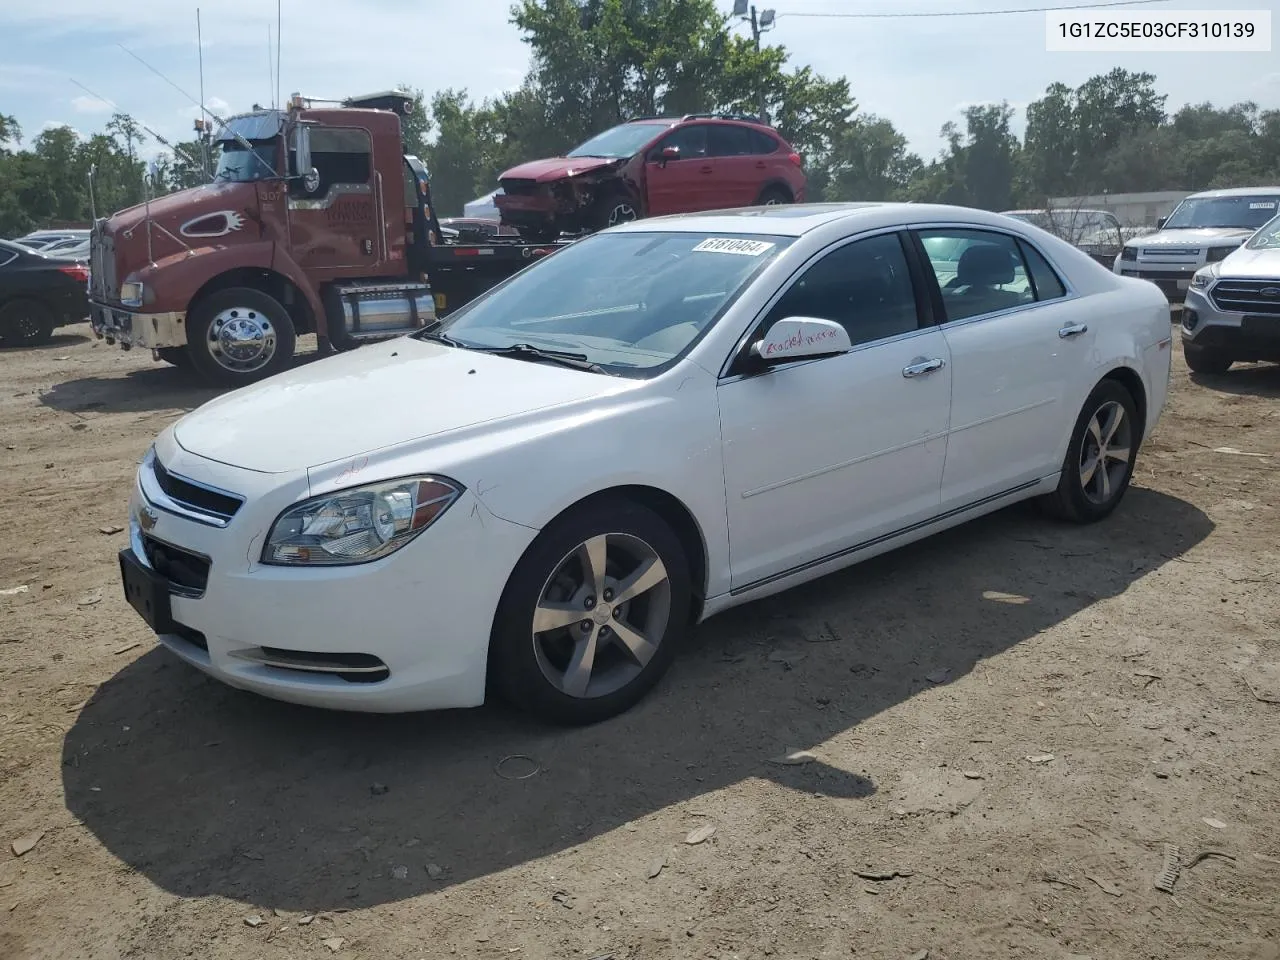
top-left (1181, 216), bottom-right (1280, 374)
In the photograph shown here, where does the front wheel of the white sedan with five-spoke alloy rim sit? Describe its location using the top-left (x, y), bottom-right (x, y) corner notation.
top-left (490, 498), bottom-right (692, 724)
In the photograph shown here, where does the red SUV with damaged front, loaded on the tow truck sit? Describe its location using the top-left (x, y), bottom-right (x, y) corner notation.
top-left (494, 114), bottom-right (805, 242)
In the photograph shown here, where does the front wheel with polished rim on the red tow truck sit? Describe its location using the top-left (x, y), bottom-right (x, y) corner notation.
top-left (187, 287), bottom-right (297, 387)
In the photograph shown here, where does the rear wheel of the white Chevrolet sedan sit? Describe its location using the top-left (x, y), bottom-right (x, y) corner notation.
top-left (1042, 380), bottom-right (1142, 524)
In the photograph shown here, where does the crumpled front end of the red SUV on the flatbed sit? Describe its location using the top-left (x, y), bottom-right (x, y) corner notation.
top-left (494, 156), bottom-right (643, 243)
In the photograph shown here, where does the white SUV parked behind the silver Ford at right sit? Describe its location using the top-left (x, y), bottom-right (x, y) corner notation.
top-left (1111, 187), bottom-right (1280, 303)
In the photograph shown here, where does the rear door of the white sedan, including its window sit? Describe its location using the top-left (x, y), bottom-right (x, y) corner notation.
top-left (919, 228), bottom-right (1094, 509)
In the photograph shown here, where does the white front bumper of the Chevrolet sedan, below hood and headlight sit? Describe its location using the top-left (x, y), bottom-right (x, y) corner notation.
top-left (120, 440), bottom-right (536, 713)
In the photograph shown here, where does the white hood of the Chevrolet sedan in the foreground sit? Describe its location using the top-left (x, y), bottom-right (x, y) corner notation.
top-left (174, 338), bottom-right (636, 474)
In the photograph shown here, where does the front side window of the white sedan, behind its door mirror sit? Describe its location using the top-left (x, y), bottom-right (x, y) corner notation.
top-left (764, 233), bottom-right (919, 346)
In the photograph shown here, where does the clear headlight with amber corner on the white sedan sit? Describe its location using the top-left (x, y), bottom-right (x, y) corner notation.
top-left (262, 476), bottom-right (463, 566)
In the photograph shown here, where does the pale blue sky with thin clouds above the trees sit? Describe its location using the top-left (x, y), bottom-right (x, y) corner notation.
top-left (0, 0), bottom-right (1280, 167)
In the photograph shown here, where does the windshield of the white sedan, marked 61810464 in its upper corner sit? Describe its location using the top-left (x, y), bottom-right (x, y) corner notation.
top-left (430, 233), bottom-right (792, 375)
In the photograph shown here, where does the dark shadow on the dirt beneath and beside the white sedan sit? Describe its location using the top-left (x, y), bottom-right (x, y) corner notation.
top-left (63, 489), bottom-right (1212, 911)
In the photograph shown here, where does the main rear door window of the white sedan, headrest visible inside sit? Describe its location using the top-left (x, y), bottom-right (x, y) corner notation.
top-left (919, 228), bottom-right (1036, 320)
